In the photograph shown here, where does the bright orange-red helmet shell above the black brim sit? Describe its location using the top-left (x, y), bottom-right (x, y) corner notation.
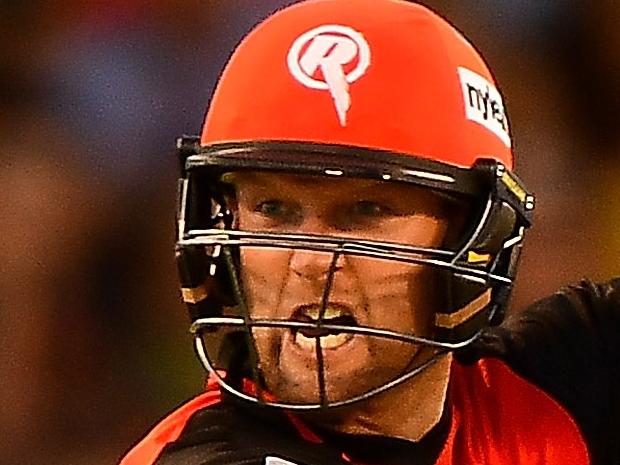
top-left (201, 0), bottom-right (513, 168)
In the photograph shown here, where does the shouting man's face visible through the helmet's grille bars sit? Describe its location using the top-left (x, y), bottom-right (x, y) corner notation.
top-left (234, 173), bottom-right (447, 403)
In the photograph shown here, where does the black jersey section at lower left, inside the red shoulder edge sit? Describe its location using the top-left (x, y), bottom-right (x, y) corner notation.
top-left (155, 398), bottom-right (346, 465)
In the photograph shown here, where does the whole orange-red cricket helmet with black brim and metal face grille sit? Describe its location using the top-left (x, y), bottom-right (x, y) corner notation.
top-left (177, 0), bottom-right (534, 409)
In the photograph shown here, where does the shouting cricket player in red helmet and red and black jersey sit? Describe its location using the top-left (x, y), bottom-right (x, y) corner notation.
top-left (121, 0), bottom-right (620, 465)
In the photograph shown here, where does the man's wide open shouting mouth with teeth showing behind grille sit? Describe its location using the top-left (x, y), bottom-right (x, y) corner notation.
top-left (292, 304), bottom-right (358, 350)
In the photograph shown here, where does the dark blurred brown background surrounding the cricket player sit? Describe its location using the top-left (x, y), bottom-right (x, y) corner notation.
top-left (0, 0), bottom-right (620, 465)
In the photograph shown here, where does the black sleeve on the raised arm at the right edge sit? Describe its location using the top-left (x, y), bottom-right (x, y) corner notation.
top-left (457, 279), bottom-right (620, 465)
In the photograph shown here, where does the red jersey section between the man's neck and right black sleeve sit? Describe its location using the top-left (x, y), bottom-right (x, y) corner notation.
top-left (439, 358), bottom-right (590, 465)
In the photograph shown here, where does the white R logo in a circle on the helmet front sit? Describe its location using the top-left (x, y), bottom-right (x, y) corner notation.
top-left (288, 25), bottom-right (370, 126)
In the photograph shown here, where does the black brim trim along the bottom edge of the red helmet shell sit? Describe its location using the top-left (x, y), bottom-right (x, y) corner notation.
top-left (177, 137), bottom-right (534, 218)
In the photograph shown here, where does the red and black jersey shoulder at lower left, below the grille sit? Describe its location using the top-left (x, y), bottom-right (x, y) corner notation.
top-left (120, 385), bottom-right (344, 465)
